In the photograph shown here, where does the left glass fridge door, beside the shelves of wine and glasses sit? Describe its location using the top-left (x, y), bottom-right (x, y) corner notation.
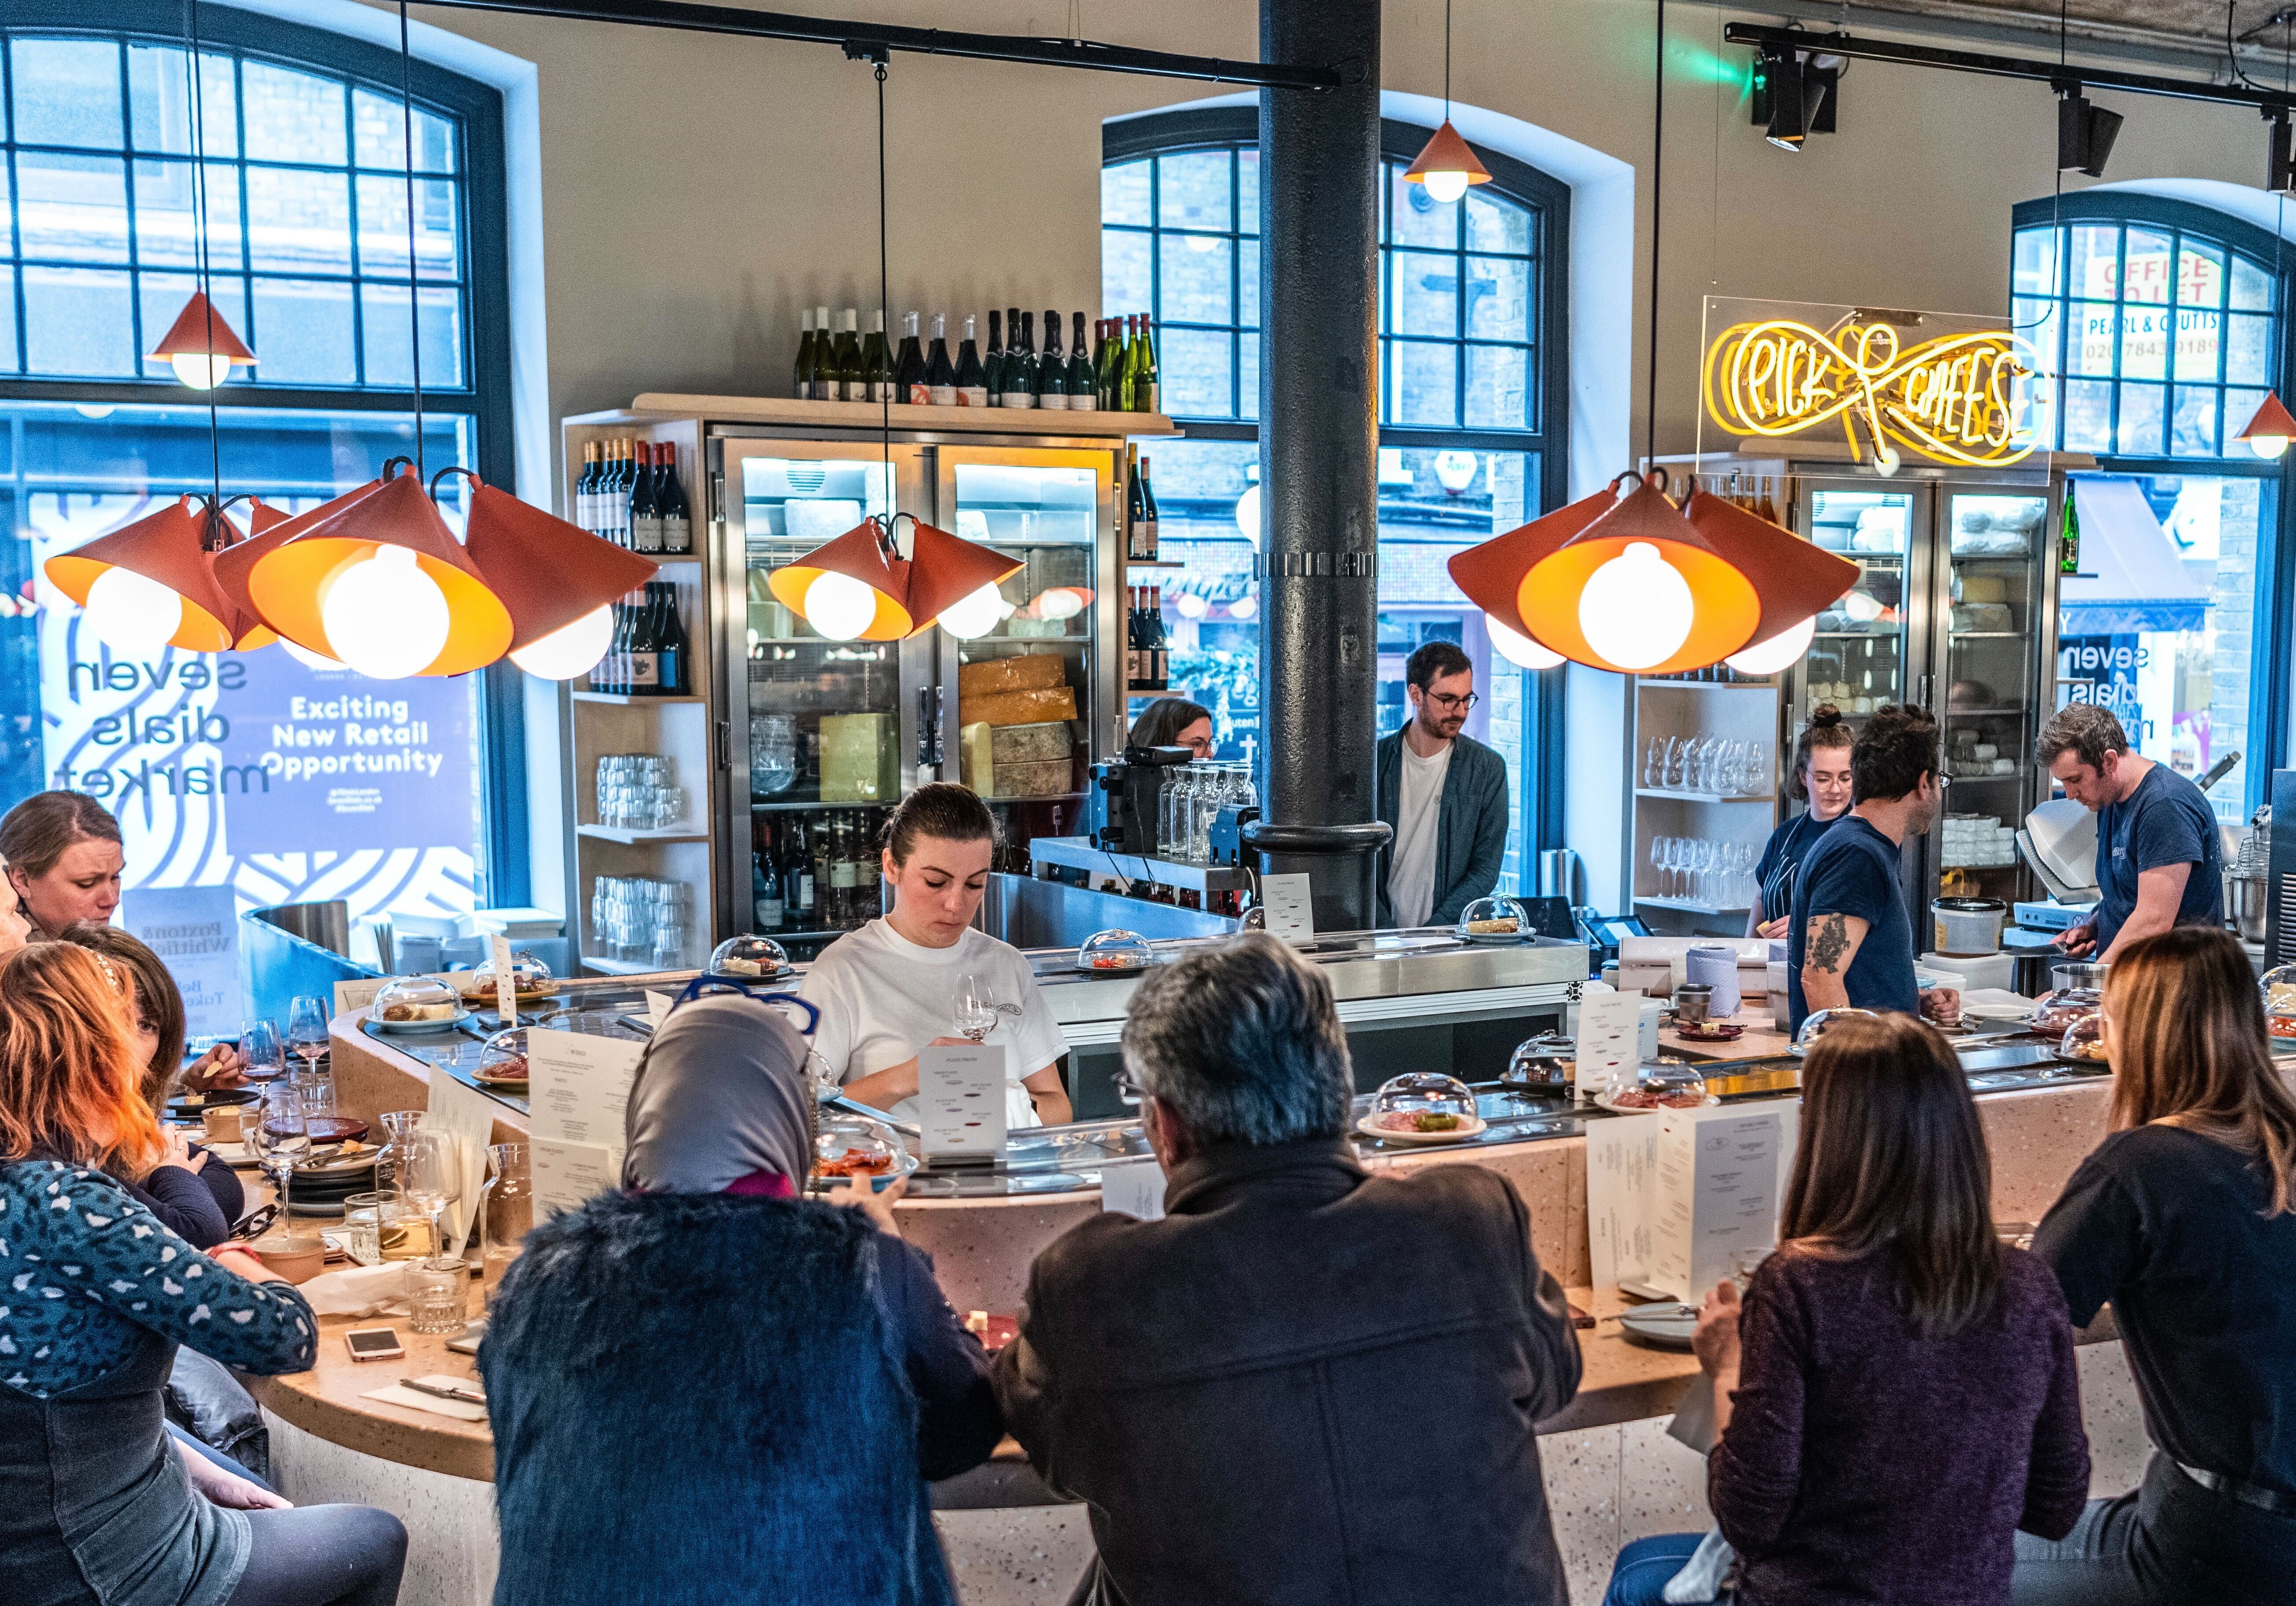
top-left (712, 436), bottom-right (937, 958)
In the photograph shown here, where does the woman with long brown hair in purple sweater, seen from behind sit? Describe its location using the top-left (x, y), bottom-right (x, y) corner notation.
top-left (1612, 1016), bottom-right (2089, 1606)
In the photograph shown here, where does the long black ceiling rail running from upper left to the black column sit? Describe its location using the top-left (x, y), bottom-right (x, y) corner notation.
top-left (422, 0), bottom-right (1359, 89)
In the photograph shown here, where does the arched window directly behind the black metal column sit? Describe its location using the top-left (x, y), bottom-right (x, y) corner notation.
top-left (1100, 110), bottom-right (1570, 889)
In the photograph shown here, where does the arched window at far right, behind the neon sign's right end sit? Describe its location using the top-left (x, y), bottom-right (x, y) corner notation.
top-left (2011, 191), bottom-right (2296, 823)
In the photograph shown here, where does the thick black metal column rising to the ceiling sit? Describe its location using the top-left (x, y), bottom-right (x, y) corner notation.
top-left (1251, 0), bottom-right (1387, 931)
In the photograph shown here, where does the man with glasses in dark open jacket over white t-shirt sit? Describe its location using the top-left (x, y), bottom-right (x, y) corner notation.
top-left (1373, 641), bottom-right (1506, 928)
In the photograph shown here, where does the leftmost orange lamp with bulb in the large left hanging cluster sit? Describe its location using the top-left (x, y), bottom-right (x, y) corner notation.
top-left (44, 496), bottom-right (234, 652)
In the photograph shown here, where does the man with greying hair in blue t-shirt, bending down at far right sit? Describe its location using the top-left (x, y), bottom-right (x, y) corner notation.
top-left (2039, 703), bottom-right (2225, 965)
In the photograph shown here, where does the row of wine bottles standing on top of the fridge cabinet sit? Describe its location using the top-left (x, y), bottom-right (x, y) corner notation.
top-left (792, 306), bottom-right (1162, 414)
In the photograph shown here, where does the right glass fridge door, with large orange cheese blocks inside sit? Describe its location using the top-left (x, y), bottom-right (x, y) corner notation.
top-left (921, 446), bottom-right (1125, 871)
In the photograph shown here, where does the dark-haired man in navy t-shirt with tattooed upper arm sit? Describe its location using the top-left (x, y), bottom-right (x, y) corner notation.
top-left (1786, 703), bottom-right (1961, 1032)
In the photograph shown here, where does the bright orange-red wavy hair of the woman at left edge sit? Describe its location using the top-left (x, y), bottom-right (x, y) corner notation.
top-left (0, 942), bottom-right (165, 1181)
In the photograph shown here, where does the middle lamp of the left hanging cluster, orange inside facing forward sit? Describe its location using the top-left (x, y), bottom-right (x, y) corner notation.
top-left (248, 469), bottom-right (512, 680)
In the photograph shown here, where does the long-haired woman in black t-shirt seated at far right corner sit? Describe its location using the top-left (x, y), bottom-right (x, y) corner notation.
top-left (2011, 926), bottom-right (2296, 1606)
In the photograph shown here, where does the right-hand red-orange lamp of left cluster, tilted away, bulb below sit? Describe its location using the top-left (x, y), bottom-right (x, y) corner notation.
top-left (452, 469), bottom-right (661, 680)
